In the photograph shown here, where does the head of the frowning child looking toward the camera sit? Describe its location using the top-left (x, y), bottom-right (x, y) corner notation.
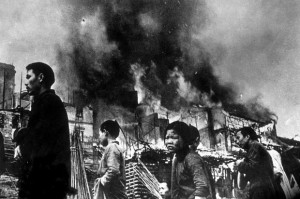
top-left (164, 121), bottom-right (192, 153)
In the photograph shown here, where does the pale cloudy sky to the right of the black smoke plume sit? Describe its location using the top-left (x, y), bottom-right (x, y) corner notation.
top-left (193, 0), bottom-right (300, 136)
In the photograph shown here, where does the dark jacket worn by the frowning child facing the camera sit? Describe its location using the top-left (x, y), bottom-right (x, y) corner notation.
top-left (171, 151), bottom-right (215, 199)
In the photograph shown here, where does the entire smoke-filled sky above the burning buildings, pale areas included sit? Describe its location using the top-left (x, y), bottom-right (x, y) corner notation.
top-left (0, 0), bottom-right (300, 137)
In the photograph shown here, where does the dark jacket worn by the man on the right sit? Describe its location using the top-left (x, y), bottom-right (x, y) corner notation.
top-left (238, 141), bottom-right (275, 199)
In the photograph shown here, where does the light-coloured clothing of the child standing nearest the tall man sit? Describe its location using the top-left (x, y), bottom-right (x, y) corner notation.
top-left (98, 141), bottom-right (127, 199)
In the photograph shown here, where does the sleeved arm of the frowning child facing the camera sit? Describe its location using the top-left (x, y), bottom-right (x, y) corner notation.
top-left (187, 154), bottom-right (209, 198)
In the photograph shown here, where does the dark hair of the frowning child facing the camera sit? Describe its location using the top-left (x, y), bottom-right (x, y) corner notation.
top-left (164, 121), bottom-right (193, 145)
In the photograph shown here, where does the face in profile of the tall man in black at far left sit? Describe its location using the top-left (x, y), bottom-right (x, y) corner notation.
top-left (25, 69), bottom-right (42, 95)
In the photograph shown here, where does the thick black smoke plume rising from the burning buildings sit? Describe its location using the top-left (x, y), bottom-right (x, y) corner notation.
top-left (58, 0), bottom-right (276, 122)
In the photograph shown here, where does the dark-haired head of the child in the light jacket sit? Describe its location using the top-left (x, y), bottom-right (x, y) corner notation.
top-left (99, 120), bottom-right (120, 146)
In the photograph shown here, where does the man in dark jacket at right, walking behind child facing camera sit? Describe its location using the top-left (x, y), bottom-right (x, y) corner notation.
top-left (236, 127), bottom-right (276, 199)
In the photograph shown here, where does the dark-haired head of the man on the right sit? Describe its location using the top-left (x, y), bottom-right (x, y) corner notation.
top-left (236, 127), bottom-right (258, 148)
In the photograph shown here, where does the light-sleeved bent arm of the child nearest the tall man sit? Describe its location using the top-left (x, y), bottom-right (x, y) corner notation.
top-left (100, 144), bottom-right (121, 187)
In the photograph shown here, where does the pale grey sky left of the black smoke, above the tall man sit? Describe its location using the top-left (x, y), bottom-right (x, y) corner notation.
top-left (0, 0), bottom-right (67, 91)
